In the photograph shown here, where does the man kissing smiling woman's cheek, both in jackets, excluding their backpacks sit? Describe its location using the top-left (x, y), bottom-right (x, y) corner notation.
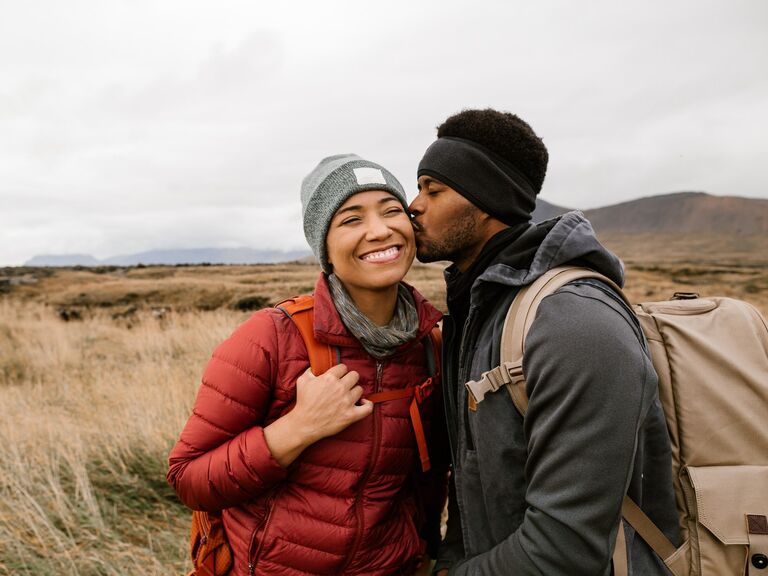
top-left (168, 110), bottom-right (677, 576)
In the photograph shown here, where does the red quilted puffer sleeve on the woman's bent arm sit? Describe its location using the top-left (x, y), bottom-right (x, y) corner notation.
top-left (167, 310), bottom-right (286, 511)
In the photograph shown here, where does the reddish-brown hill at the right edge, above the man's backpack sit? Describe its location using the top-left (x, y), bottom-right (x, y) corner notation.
top-left (584, 192), bottom-right (768, 236)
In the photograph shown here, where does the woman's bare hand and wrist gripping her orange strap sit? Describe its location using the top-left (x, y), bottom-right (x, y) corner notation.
top-left (264, 364), bottom-right (373, 466)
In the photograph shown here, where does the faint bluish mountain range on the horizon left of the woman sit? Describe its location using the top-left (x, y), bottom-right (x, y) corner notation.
top-left (24, 248), bottom-right (310, 266)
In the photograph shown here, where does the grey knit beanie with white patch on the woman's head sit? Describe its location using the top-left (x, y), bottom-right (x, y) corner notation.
top-left (301, 154), bottom-right (408, 273)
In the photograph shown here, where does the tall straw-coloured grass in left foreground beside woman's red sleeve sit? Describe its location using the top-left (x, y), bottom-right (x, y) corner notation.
top-left (0, 300), bottom-right (244, 575)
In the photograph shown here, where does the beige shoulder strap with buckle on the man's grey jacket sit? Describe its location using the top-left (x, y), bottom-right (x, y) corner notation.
top-left (466, 266), bottom-right (627, 415)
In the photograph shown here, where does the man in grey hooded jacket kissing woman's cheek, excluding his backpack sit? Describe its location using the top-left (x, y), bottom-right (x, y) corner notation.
top-left (410, 110), bottom-right (679, 576)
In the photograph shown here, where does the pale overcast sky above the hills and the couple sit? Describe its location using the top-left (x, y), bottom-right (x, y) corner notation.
top-left (0, 0), bottom-right (768, 265)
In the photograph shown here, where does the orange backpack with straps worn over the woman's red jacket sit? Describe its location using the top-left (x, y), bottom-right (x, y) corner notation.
top-left (187, 295), bottom-right (442, 576)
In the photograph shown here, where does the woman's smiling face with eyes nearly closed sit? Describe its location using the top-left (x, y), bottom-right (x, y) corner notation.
top-left (325, 190), bottom-right (416, 298)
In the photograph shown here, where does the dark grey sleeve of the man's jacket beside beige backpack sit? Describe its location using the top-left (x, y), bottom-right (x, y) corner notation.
top-left (450, 285), bottom-right (654, 576)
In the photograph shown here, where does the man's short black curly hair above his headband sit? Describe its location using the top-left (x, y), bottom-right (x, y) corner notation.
top-left (437, 108), bottom-right (549, 193)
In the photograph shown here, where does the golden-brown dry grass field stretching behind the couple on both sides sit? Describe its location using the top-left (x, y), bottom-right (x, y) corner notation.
top-left (0, 238), bottom-right (768, 575)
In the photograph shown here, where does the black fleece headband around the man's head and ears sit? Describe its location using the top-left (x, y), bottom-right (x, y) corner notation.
top-left (418, 137), bottom-right (537, 226)
